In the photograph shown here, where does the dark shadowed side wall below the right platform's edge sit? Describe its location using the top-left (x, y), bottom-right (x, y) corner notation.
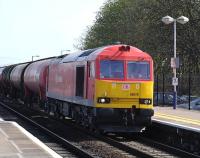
top-left (144, 120), bottom-right (200, 157)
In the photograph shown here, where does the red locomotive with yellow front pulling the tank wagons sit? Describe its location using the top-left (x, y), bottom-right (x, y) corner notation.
top-left (46, 45), bottom-right (153, 132)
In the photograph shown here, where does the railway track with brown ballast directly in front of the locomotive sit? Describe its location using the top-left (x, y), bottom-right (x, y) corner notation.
top-left (72, 123), bottom-right (200, 158)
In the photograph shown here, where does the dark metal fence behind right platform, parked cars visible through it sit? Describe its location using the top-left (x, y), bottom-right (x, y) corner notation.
top-left (154, 73), bottom-right (200, 109)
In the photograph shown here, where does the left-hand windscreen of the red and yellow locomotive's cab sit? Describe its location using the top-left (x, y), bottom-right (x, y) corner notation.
top-left (100, 60), bottom-right (124, 79)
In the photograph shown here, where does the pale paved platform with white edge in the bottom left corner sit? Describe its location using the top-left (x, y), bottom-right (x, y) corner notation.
top-left (0, 120), bottom-right (61, 158)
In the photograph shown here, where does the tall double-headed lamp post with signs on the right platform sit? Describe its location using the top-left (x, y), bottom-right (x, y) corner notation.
top-left (162, 16), bottom-right (189, 109)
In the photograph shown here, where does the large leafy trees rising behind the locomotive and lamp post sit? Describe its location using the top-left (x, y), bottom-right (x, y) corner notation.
top-left (77, 0), bottom-right (200, 73)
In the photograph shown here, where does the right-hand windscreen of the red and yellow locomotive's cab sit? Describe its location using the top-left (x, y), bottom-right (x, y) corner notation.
top-left (127, 61), bottom-right (150, 80)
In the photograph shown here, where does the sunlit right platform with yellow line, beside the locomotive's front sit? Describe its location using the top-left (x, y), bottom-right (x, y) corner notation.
top-left (152, 106), bottom-right (200, 132)
